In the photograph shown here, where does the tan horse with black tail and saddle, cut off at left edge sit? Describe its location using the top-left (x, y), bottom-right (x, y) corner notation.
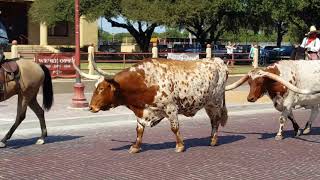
top-left (0, 59), bottom-right (53, 148)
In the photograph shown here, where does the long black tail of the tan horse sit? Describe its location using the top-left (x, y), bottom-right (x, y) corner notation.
top-left (40, 64), bottom-right (53, 111)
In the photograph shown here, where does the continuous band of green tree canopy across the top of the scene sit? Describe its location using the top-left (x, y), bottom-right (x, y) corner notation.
top-left (29, 0), bottom-right (320, 48)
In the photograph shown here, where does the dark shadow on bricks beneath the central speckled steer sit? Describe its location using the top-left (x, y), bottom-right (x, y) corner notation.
top-left (111, 135), bottom-right (245, 152)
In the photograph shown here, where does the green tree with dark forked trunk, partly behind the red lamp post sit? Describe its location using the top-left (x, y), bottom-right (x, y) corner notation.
top-left (30, 0), bottom-right (168, 52)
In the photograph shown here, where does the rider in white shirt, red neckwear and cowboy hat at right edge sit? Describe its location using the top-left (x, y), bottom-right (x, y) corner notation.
top-left (300, 26), bottom-right (320, 60)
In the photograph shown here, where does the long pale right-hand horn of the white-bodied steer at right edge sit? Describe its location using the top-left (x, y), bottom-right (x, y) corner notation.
top-left (258, 70), bottom-right (320, 94)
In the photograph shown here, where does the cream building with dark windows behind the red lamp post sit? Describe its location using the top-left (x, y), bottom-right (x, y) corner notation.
top-left (0, 0), bottom-right (98, 47)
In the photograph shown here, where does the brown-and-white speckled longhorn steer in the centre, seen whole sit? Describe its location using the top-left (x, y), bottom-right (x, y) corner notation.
top-left (75, 58), bottom-right (228, 153)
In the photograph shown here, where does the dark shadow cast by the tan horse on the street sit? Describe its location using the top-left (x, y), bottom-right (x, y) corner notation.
top-left (7, 135), bottom-right (83, 149)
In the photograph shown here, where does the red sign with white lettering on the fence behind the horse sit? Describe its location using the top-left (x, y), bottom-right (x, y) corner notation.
top-left (35, 53), bottom-right (76, 78)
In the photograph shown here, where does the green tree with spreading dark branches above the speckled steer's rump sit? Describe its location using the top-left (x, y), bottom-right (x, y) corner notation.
top-left (168, 0), bottom-right (243, 45)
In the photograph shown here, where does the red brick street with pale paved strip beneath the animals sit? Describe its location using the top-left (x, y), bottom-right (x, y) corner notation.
top-left (0, 81), bottom-right (320, 180)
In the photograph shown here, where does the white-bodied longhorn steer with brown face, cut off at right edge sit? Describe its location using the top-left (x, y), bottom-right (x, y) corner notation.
top-left (226, 60), bottom-right (320, 140)
